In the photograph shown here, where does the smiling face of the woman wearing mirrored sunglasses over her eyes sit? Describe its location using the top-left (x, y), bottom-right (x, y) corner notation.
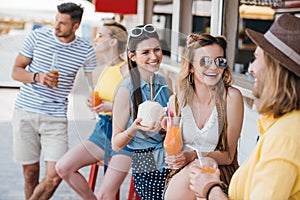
top-left (191, 44), bottom-right (224, 86)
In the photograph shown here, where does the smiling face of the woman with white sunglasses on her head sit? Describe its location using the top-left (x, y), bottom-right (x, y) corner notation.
top-left (129, 38), bottom-right (163, 74)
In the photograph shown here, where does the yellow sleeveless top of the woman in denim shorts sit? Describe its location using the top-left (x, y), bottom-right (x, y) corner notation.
top-left (95, 61), bottom-right (126, 114)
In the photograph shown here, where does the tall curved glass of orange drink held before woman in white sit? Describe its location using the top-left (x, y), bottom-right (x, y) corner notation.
top-left (164, 117), bottom-right (183, 168)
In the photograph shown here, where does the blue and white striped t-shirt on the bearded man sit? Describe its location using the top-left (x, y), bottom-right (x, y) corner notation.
top-left (16, 28), bottom-right (96, 117)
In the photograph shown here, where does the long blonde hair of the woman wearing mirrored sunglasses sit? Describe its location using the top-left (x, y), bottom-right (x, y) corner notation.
top-left (178, 34), bottom-right (233, 151)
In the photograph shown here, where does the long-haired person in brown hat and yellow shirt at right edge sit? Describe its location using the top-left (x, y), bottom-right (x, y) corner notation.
top-left (190, 14), bottom-right (300, 200)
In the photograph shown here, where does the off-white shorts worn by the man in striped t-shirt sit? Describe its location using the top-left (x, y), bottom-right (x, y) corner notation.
top-left (12, 108), bottom-right (68, 165)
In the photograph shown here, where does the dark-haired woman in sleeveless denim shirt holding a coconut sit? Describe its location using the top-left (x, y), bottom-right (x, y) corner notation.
top-left (112, 24), bottom-right (170, 200)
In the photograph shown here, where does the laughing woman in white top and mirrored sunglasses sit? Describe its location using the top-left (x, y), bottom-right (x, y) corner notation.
top-left (165, 34), bottom-right (244, 200)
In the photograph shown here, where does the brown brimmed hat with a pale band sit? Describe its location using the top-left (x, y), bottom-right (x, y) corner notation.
top-left (246, 14), bottom-right (300, 77)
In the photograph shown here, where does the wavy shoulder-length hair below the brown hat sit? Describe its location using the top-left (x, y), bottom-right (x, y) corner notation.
top-left (257, 52), bottom-right (300, 118)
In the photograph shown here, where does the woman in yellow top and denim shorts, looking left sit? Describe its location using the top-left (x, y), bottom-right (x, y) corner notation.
top-left (56, 21), bottom-right (131, 200)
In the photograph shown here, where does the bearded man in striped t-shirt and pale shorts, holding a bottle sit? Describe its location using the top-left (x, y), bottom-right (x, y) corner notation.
top-left (12, 3), bottom-right (96, 200)
